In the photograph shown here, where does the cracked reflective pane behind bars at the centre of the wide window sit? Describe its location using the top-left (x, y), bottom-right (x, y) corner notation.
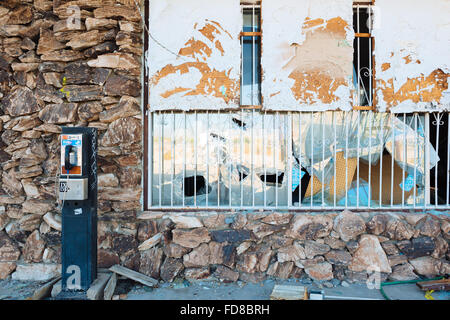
top-left (220, 112), bottom-right (288, 206)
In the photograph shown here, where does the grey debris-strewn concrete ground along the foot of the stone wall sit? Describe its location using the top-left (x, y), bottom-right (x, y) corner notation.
top-left (0, 279), bottom-right (450, 300)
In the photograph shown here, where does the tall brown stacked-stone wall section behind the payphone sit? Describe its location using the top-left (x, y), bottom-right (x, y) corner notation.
top-left (0, 0), bottom-right (143, 279)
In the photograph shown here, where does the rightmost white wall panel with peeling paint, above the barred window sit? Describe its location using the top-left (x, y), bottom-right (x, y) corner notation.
top-left (373, 0), bottom-right (450, 112)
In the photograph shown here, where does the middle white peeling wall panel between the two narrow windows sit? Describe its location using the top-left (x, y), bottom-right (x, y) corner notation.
top-left (261, 0), bottom-right (354, 111)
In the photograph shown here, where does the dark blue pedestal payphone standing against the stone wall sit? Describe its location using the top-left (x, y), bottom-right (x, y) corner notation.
top-left (59, 127), bottom-right (97, 293)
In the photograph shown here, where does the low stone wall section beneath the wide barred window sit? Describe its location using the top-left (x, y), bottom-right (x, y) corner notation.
top-left (128, 211), bottom-right (450, 285)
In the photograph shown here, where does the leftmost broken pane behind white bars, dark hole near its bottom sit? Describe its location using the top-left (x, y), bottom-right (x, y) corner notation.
top-left (152, 113), bottom-right (229, 206)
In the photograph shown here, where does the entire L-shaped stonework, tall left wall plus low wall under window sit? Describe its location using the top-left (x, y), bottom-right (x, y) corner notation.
top-left (0, 0), bottom-right (450, 282)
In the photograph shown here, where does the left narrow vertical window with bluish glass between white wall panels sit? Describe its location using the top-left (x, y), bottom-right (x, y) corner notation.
top-left (241, 4), bottom-right (261, 106)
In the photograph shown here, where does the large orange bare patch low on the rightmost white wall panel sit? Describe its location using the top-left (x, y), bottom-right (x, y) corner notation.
top-left (378, 69), bottom-right (450, 107)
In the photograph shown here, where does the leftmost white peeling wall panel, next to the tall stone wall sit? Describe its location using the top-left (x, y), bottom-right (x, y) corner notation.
top-left (147, 0), bottom-right (242, 110)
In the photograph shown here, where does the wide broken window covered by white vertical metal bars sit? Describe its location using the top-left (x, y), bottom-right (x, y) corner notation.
top-left (148, 110), bottom-right (450, 210)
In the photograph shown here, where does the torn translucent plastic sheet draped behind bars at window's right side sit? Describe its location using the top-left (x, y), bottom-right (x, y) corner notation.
top-left (293, 111), bottom-right (439, 190)
